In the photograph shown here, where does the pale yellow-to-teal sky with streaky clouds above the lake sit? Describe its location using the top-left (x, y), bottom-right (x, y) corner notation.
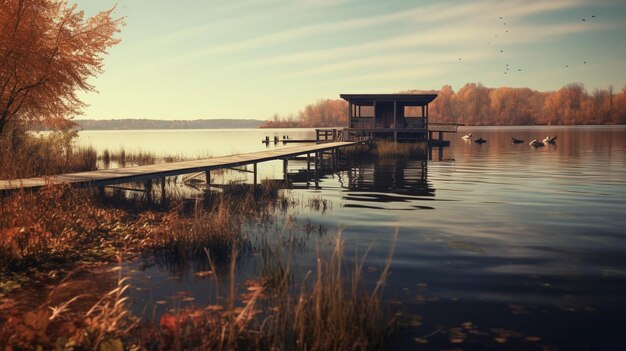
top-left (74, 0), bottom-right (626, 119)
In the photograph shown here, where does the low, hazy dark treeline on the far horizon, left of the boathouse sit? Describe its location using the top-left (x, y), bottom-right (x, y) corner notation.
top-left (74, 119), bottom-right (263, 130)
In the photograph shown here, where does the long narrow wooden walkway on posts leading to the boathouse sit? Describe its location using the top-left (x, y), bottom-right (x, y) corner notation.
top-left (0, 142), bottom-right (357, 193)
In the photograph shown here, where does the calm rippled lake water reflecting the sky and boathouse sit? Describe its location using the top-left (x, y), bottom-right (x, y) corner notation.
top-left (80, 127), bottom-right (626, 350)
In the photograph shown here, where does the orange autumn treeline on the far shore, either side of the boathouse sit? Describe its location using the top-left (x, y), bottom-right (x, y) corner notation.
top-left (261, 83), bottom-right (626, 127)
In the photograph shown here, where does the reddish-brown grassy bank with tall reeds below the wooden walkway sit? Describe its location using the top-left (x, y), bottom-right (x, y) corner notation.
top-left (0, 182), bottom-right (394, 350)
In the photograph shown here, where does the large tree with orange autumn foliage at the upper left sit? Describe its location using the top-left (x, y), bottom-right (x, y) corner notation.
top-left (0, 0), bottom-right (123, 136)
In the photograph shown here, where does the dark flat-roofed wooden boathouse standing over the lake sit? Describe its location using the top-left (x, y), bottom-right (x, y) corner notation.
top-left (339, 94), bottom-right (437, 142)
